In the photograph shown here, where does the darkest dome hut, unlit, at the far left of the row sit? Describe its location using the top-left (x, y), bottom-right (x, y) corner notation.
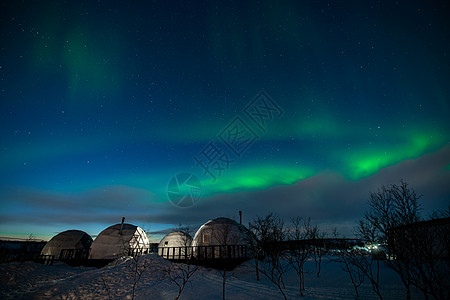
top-left (41, 230), bottom-right (92, 259)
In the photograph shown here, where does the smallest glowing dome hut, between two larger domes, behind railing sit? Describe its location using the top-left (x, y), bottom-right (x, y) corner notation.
top-left (158, 231), bottom-right (192, 259)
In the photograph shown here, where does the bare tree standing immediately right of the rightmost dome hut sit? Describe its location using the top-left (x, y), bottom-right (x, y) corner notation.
top-left (251, 213), bottom-right (289, 299)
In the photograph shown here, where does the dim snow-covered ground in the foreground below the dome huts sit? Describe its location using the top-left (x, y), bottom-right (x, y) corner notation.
top-left (0, 254), bottom-right (423, 299)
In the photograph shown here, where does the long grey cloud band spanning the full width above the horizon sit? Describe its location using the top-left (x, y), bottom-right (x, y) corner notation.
top-left (0, 147), bottom-right (450, 235)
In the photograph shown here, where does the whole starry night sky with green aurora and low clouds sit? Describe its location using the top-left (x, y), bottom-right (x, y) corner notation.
top-left (0, 0), bottom-right (450, 240)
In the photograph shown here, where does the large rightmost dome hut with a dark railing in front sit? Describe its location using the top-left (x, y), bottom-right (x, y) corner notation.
top-left (192, 217), bottom-right (250, 259)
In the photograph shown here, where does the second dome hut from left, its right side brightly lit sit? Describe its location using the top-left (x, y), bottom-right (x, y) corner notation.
top-left (89, 223), bottom-right (150, 259)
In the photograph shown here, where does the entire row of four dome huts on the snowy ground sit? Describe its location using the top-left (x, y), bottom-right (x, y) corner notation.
top-left (41, 217), bottom-right (249, 260)
